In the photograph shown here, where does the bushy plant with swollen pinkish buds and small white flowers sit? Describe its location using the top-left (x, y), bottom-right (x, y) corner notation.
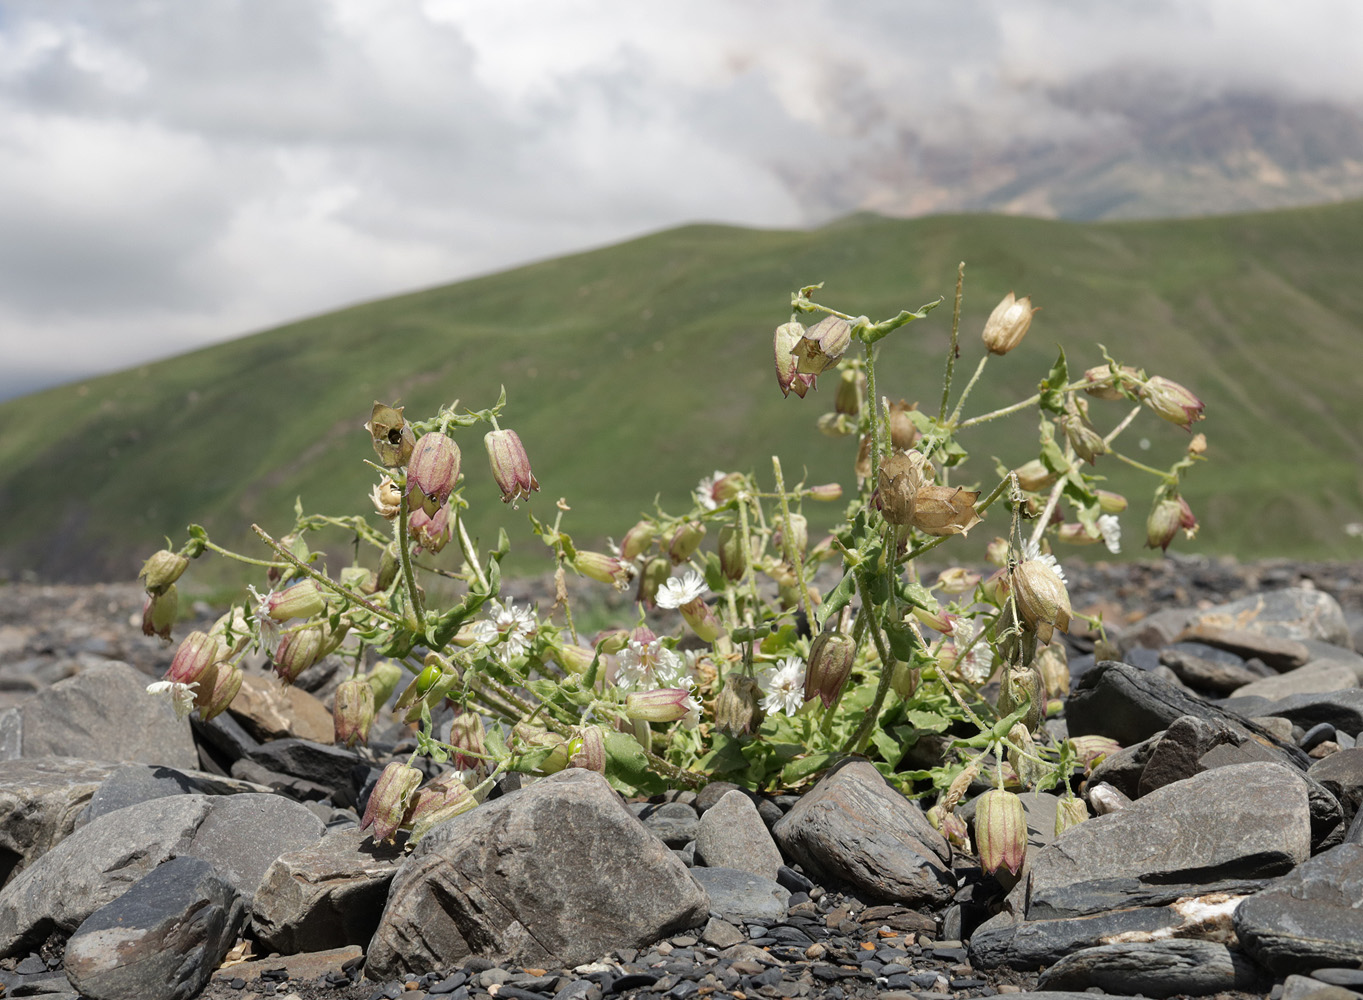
top-left (142, 266), bottom-right (1206, 872)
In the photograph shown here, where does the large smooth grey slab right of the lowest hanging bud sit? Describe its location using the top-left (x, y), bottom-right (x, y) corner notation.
top-left (1018, 763), bottom-right (1311, 918)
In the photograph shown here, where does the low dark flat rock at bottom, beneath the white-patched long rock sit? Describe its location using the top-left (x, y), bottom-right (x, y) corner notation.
top-left (1037, 940), bottom-right (1264, 997)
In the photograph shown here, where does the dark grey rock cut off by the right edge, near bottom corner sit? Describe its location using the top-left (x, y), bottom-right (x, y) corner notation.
top-left (1235, 843), bottom-right (1363, 974)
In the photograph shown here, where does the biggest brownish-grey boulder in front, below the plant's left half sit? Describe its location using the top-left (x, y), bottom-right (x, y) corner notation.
top-left (365, 768), bottom-right (710, 977)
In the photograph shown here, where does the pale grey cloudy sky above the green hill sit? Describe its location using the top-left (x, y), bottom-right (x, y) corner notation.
top-left (0, 0), bottom-right (1363, 398)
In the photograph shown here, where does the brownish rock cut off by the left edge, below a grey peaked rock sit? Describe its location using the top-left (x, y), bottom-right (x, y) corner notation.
top-left (0, 757), bottom-right (119, 884)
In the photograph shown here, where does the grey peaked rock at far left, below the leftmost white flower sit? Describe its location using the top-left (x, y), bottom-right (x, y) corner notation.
top-left (22, 661), bottom-right (199, 770)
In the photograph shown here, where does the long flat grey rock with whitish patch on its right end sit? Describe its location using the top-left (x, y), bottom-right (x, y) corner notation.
top-left (970, 887), bottom-right (1257, 969)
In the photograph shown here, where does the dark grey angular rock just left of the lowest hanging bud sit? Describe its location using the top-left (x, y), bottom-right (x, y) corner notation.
top-left (771, 760), bottom-right (955, 906)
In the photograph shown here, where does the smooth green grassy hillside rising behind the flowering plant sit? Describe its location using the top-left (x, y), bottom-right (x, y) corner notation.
top-left (0, 203), bottom-right (1363, 591)
